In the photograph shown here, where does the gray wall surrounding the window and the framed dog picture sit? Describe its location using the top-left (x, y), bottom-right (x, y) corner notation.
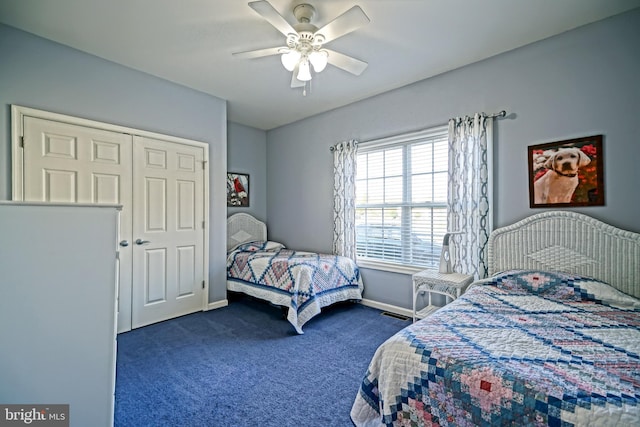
top-left (267, 9), bottom-right (640, 308)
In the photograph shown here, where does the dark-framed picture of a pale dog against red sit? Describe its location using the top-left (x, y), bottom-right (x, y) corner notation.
top-left (528, 135), bottom-right (604, 208)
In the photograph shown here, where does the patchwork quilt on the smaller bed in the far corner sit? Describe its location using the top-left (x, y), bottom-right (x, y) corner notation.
top-left (227, 241), bottom-right (363, 334)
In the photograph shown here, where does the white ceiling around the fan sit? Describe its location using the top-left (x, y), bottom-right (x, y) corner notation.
top-left (0, 0), bottom-right (640, 130)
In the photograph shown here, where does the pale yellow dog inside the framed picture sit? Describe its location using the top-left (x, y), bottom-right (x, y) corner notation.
top-left (533, 147), bottom-right (591, 204)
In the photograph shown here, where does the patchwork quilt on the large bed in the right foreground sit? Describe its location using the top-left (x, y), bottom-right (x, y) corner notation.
top-left (351, 270), bottom-right (640, 426)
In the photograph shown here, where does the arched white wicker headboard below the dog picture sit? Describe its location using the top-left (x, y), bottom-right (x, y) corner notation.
top-left (488, 211), bottom-right (640, 298)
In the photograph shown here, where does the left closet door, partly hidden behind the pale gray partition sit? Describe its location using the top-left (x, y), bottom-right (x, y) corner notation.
top-left (23, 116), bottom-right (133, 332)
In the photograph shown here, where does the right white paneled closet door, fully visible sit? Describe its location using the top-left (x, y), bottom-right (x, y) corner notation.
top-left (132, 136), bottom-right (205, 328)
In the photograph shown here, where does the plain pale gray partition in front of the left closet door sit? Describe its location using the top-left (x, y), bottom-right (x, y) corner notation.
top-left (0, 202), bottom-right (118, 426)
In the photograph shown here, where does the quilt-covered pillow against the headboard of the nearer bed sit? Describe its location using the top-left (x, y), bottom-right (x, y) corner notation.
top-left (488, 270), bottom-right (640, 309)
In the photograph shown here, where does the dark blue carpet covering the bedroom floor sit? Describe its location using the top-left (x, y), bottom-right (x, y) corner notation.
top-left (115, 297), bottom-right (409, 427)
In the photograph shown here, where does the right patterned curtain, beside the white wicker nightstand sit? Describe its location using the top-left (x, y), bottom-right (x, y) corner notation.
top-left (447, 113), bottom-right (493, 279)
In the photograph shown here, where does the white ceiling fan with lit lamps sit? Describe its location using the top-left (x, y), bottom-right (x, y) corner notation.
top-left (233, 0), bottom-right (369, 95)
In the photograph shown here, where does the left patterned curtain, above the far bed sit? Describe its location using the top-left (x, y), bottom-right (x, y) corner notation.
top-left (333, 140), bottom-right (358, 260)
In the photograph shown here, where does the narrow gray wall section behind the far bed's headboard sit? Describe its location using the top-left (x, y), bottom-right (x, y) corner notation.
top-left (227, 122), bottom-right (267, 222)
